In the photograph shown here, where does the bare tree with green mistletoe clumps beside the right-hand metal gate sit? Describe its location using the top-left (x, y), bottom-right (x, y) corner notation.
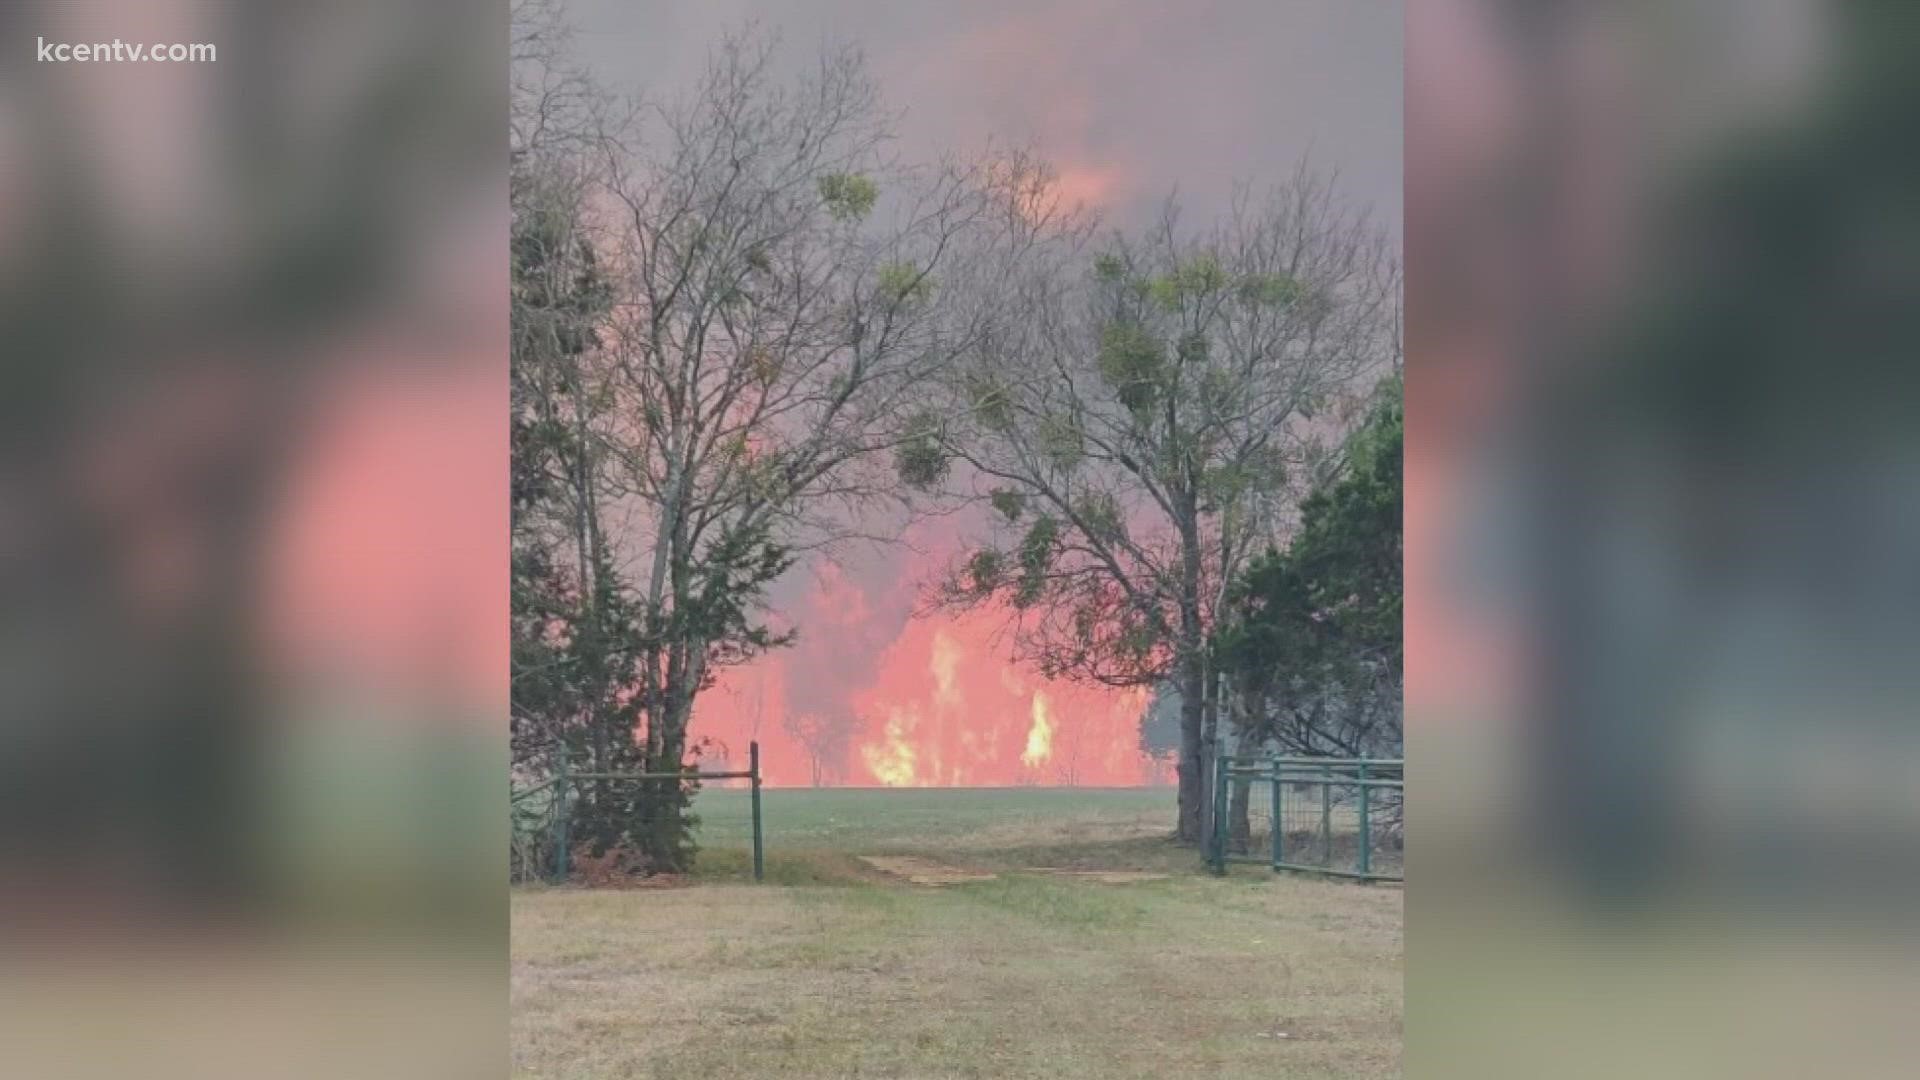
top-left (941, 165), bottom-right (1394, 842)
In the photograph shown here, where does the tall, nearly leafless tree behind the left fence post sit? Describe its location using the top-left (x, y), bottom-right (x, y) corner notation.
top-left (572, 33), bottom-right (1052, 865)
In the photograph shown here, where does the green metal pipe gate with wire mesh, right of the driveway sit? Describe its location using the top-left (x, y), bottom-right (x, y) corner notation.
top-left (1208, 755), bottom-right (1405, 882)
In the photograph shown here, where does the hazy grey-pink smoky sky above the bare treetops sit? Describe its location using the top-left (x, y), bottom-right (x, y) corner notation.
top-left (570, 0), bottom-right (1402, 234)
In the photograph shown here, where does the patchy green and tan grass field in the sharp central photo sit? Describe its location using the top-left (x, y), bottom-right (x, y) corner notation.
top-left (513, 788), bottom-right (1402, 1080)
